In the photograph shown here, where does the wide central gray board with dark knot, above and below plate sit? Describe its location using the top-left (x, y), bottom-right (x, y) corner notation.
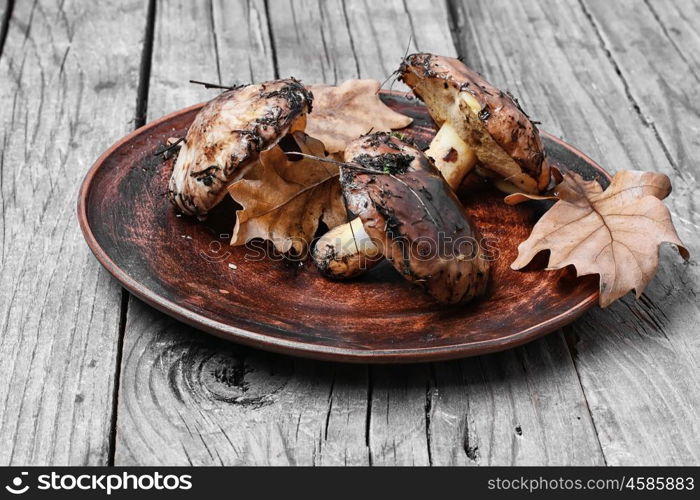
top-left (115, 2), bottom-right (602, 465)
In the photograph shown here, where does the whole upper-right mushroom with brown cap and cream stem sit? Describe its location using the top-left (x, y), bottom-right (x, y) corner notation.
top-left (399, 53), bottom-right (550, 193)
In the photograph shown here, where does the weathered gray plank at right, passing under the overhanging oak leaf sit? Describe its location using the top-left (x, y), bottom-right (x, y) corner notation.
top-left (456, 1), bottom-right (700, 464)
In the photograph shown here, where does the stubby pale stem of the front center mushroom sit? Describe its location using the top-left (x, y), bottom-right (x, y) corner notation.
top-left (312, 218), bottom-right (383, 279)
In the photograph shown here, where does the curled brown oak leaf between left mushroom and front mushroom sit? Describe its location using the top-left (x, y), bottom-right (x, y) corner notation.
top-left (228, 132), bottom-right (347, 255)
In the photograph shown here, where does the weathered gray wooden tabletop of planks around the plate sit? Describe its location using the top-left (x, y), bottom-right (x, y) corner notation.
top-left (0, 0), bottom-right (700, 465)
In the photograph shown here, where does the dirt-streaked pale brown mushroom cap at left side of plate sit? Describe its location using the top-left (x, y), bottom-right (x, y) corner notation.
top-left (168, 78), bottom-right (313, 217)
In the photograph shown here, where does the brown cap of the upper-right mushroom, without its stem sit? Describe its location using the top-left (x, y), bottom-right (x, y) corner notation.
top-left (399, 53), bottom-right (549, 192)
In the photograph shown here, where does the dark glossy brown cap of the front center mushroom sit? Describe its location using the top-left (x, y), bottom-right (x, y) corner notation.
top-left (340, 133), bottom-right (489, 303)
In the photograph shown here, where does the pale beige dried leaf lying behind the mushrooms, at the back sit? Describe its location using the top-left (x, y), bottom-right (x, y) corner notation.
top-left (306, 80), bottom-right (413, 153)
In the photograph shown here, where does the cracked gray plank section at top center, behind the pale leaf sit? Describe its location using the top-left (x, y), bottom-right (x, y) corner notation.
top-left (270, 0), bottom-right (455, 84)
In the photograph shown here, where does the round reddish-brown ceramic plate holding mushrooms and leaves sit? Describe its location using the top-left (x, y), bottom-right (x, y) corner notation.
top-left (78, 93), bottom-right (609, 363)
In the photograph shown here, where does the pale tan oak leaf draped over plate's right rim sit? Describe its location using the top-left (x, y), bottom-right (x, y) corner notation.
top-left (506, 170), bottom-right (689, 307)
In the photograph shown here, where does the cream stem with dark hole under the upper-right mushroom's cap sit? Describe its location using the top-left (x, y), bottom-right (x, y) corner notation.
top-left (425, 122), bottom-right (476, 191)
